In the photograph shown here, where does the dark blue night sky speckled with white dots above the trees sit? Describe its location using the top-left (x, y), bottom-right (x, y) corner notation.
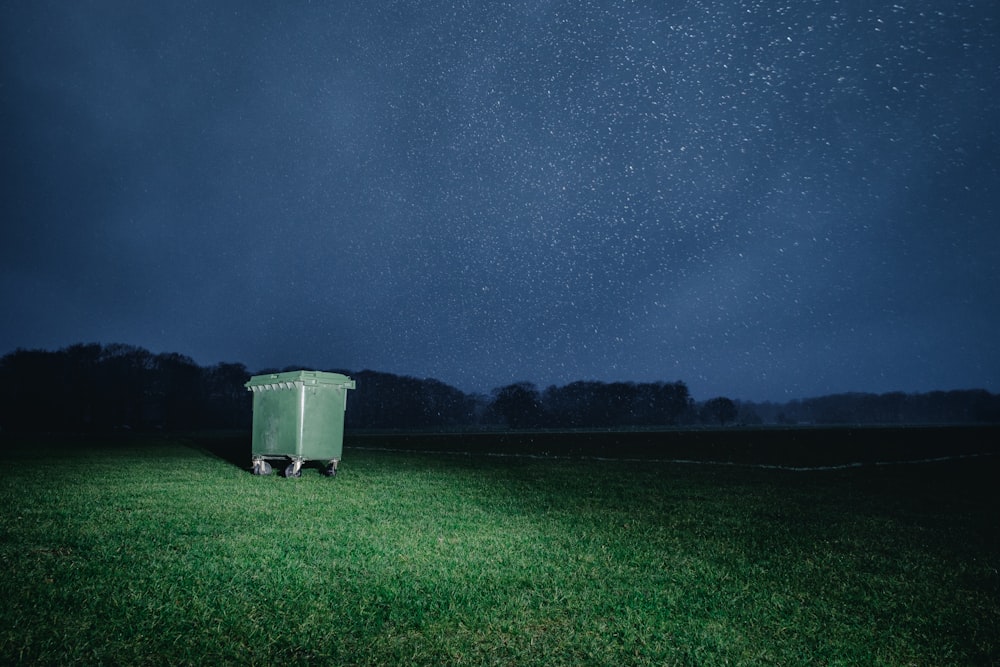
top-left (0, 0), bottom-right (1000, 401)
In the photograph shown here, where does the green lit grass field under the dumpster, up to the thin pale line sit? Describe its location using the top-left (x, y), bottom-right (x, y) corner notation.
top-left (0, 440), bottom-right (1000, 665)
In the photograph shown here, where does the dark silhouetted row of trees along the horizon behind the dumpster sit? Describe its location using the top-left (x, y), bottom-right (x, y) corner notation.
top-left (0, 343), bottom-right (1000, 431)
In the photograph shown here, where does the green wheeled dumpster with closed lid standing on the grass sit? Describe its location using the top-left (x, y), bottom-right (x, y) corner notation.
top-left (244, 371), bottom-right (354, 477)
